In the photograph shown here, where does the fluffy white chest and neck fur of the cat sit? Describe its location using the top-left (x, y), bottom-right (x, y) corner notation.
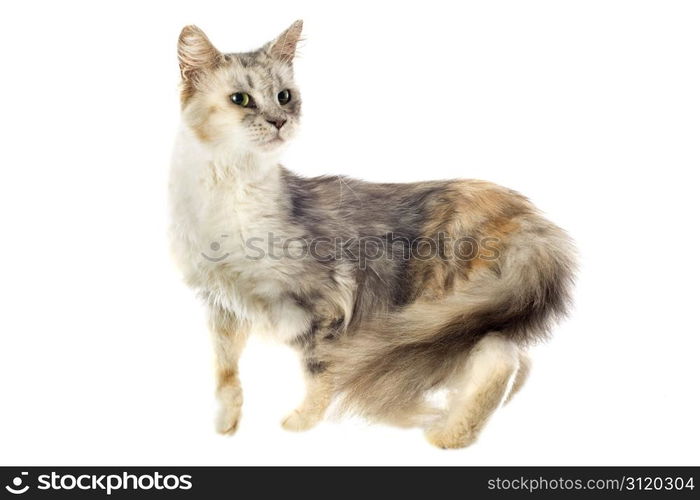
top-left (170, 130), bottom-right (311, 341)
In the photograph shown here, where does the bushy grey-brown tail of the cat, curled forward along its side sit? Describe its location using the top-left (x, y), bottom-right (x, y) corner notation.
top-left (323, 223), bottom-right (575, 425)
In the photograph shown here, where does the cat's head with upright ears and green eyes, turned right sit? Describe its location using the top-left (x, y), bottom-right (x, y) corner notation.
top-left (178, 21), bottom-right (302, 153)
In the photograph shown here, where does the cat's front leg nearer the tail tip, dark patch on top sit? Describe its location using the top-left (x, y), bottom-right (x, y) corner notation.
top-left (282, 358), bottom-right (333, 432)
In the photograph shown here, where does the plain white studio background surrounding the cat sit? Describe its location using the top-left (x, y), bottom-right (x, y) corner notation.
top-left (0, 0), bottom-right (700, 465)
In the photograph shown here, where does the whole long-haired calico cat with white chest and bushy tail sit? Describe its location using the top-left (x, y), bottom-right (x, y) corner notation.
top-left (170, 21), bottom-right (575, 448)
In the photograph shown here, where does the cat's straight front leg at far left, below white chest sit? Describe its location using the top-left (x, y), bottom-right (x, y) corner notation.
top-left (209, 307), bottom-right (249, 434)
